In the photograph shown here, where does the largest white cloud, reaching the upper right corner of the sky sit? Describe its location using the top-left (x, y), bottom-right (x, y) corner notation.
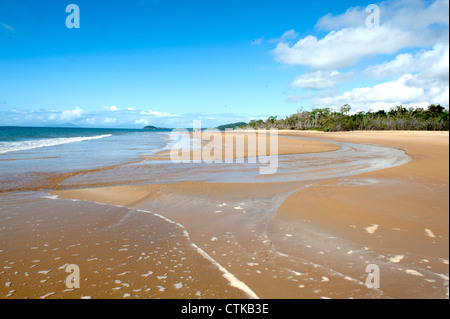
top-left (272, 0), bottom-right (449, 69)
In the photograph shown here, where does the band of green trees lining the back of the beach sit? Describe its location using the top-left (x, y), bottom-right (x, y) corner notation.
top-left (246, 104), bottom-right (449, 131)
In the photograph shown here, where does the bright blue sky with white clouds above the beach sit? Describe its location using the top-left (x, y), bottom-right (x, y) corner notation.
top-left (0, 0), bottom-right (449, 127)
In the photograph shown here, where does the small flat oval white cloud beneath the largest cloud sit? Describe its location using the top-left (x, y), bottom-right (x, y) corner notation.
top-left (291, 70), bottom-right (351, 90)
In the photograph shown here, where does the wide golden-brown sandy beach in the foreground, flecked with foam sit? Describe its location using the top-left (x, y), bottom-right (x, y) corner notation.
top-left (0, 131), bottom-right (449, 299)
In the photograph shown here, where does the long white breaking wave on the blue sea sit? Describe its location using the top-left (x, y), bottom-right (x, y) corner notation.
top-left (0, 134), bottom-right (112, 154)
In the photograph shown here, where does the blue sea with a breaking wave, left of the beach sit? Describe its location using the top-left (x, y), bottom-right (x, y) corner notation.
top-left (0, 127), bottom-right (170, 192)
